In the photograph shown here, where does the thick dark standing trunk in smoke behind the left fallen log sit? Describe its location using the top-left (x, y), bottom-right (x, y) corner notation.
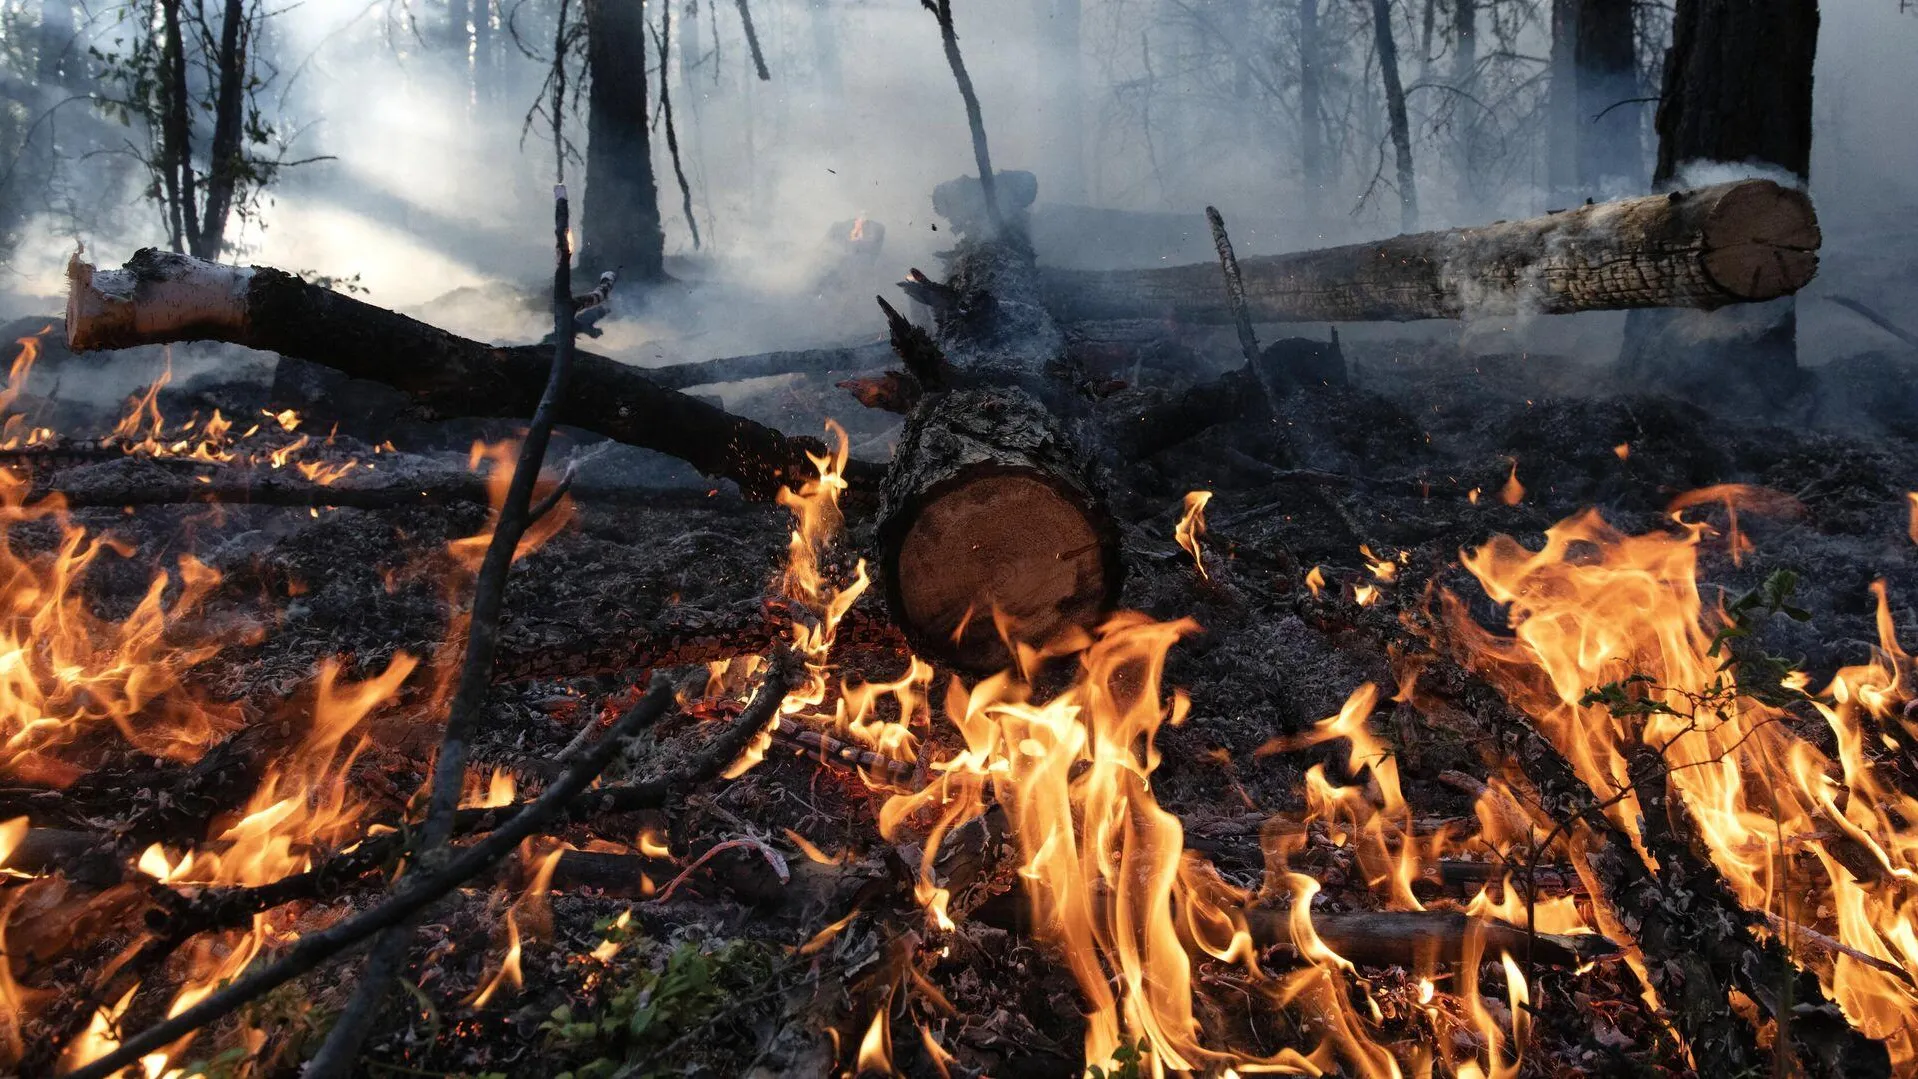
top-left (579, 0), bottom-right (666, 282)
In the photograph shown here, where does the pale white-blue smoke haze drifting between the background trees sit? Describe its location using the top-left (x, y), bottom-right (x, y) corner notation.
top-left (0, 0), bottom-right (1918, 364)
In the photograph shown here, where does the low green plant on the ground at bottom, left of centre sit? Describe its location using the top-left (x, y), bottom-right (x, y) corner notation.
top-left (541, 939), bottom-right (771, 1079)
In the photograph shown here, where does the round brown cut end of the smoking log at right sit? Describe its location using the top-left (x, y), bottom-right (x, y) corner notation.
top-left (1703, 180), bottom-right (1822, 301)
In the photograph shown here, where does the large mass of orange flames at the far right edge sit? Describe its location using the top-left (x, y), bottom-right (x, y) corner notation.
top-left (1442, 491), bottom-right (1918, 1071)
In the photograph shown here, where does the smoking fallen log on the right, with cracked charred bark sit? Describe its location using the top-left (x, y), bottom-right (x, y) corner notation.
top-left (1041, 180), bottom-right (1820, 322)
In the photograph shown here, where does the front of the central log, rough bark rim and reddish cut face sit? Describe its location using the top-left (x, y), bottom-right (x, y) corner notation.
top-left (878, 387), bottom-right (1122, 673)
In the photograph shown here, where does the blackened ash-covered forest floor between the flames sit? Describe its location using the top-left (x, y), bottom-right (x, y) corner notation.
top-left (12, 314), bottom-right (1918, 1075)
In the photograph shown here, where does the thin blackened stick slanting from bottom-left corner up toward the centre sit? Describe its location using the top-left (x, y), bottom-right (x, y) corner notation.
top-left (58, 682), bottom-right (673, 1079)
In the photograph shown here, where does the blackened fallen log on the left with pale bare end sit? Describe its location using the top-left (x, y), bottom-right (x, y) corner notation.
top-left (67, 249), bottom-right (855, 500)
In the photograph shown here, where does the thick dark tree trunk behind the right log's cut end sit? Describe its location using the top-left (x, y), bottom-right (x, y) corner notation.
top-left (1625, 0), bottom-right (1818, 408)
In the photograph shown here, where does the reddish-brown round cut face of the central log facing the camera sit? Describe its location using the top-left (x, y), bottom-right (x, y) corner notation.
top-left (894, 470), bottom-right (1111, 669)
